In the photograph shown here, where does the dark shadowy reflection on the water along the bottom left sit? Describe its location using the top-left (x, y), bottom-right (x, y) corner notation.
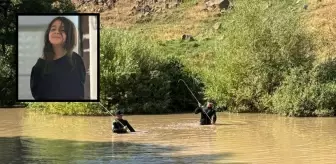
top-left (0, 137), bottom-right (235, 164)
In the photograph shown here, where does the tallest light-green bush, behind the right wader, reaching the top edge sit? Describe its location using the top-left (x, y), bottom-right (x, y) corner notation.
top-left (197, 0), bottom-right (314, 112)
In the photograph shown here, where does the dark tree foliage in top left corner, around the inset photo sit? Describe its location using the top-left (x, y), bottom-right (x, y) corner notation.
top-left (0, 0), bottom-right (76, 106)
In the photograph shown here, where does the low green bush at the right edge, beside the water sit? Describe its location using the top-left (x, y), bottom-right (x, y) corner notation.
top-left (271, 60), bottom-right (336, 116)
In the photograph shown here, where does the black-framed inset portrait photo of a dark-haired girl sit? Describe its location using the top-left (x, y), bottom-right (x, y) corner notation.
top-left (17, 14), bottom-right (99, 102)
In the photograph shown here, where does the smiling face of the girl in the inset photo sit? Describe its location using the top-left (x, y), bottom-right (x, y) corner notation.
top-left (49, 20), bottom-right (66, 45)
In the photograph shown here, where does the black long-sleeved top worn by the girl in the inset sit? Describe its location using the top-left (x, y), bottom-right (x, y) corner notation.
top-left (30, 52), bottom-right (86, 100)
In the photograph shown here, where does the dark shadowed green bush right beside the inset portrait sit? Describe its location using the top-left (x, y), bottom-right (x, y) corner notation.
top-left (100, 29), bottom-right (202, 113)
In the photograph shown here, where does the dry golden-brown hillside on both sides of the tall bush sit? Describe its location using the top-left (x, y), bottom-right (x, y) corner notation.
top-left (73, 0), bottom-right (336, 57)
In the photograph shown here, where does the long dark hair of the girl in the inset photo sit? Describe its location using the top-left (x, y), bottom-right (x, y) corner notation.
top-left (43, 17), bottom-right (77, 73)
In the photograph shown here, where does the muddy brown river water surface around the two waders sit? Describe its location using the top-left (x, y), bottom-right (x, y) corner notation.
top-left (0, 109), bottom-right (336, 164)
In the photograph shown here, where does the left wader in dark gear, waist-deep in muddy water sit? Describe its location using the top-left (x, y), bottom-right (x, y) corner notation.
top-left (112, 110), bottom-right (135, 133)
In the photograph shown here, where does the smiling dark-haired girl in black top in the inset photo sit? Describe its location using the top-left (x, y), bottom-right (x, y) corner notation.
top-left (30, 17), bottom-right (86, 100)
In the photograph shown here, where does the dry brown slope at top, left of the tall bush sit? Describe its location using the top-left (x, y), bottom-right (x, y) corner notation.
top-left (78, 0), bottom-right (224, 40)
